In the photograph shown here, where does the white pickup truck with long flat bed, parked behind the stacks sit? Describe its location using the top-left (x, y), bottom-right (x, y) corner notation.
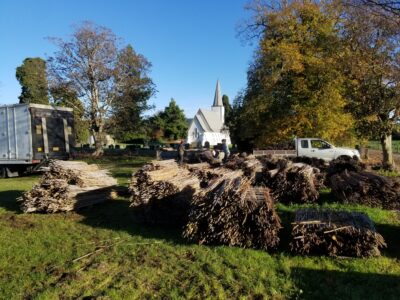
top-left (253, 138), bottom-right (360, 161)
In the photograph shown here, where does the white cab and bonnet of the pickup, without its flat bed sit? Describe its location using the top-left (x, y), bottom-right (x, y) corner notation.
top-left (296, 138), bottom-right (360, 161)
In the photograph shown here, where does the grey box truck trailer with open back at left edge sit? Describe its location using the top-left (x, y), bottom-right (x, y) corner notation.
top-left (0, 104), bottom-right (74, 178)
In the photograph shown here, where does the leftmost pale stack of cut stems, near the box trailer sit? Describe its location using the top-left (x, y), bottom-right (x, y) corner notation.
top-left (18, 160), bottom-right (117, 213)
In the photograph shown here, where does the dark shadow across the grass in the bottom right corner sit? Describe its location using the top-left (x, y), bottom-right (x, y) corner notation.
top-left (291, 268), bottom-right (400, 300)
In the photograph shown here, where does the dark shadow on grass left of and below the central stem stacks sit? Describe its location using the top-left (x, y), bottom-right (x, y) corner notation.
top-left (77, 200), bottom-right (188, 244)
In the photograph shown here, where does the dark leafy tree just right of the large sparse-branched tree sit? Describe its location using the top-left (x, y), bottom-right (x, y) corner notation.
top-left (110, 45), bottom-right (155, 141)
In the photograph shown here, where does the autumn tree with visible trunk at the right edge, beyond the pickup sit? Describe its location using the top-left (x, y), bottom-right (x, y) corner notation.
top-left (343, 2), bottom-right (400, 168)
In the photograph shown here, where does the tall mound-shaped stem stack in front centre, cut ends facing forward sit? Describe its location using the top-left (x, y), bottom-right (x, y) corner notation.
top-left (183, 170), bottom-right (281, 249)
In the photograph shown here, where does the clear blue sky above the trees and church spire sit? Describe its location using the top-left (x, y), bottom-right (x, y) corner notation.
top-left (0, 0), bottom-right (253, 117)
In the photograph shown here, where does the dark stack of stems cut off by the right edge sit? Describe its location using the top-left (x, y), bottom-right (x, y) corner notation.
top-left (329, 170), bottom-right (400, 209)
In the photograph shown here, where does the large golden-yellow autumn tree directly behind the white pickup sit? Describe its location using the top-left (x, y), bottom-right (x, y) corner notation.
top-left (234, 1), bottom-right (353, 147)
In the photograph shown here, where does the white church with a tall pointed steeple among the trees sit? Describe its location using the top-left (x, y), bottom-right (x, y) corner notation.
top-left (187, 81), bottom-right (231, 147)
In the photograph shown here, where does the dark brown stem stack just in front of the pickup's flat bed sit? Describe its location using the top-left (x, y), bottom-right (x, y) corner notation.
top-left (263, 158), bottom-right (324, 203)
